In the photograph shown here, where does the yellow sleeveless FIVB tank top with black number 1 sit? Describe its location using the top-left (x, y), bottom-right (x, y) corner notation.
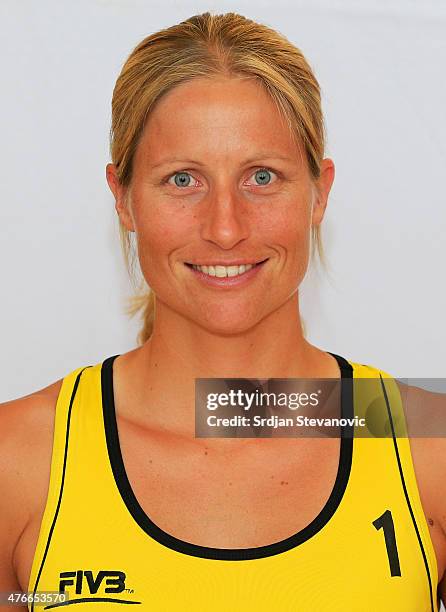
top-left (28, 353), bottom-right (439, 612)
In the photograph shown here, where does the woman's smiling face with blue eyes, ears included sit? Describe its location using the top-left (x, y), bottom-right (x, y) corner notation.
top-left (107, 77), bottom-right (334, 333)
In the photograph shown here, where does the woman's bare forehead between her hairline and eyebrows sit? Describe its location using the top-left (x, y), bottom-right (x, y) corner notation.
top-left (139, 77), bottom-right (299, 164)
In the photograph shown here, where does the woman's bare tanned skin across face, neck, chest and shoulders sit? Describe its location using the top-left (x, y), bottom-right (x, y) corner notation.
top-left (0, 73), bottom-right (446, 609)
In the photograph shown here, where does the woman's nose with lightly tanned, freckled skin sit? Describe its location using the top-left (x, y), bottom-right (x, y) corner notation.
top-left (200, 181), bottom-right (250, 249)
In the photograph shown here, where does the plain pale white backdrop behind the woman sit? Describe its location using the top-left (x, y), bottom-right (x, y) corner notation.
top-left (0, 0), bottom-right (446, 401)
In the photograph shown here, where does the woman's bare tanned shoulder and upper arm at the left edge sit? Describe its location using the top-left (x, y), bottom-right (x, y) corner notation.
top-left (0, 379), bottom-right (63, 591)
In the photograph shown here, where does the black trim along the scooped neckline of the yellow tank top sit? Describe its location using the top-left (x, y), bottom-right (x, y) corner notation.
top-left (101, 351), bottom-right (354, 561)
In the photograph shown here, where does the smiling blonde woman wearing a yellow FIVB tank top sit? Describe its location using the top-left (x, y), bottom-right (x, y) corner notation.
top-left (0, 13), bottom-right (446, 612)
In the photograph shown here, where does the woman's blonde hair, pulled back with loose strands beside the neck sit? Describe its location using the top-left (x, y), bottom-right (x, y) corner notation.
top-left (110, 12), bottom-right (326, 345)
